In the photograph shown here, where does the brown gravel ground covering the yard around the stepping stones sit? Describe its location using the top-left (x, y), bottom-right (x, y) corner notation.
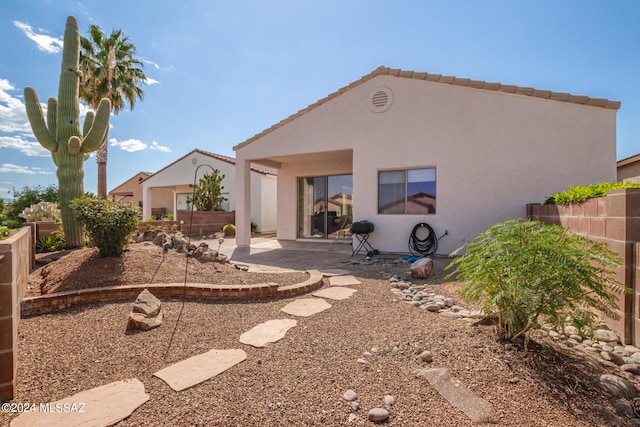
top-left (0, 245), bottom-right (632, 427)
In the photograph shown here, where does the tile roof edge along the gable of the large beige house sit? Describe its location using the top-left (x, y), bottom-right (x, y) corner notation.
top-left (233, 66), bottom-right (620, 151)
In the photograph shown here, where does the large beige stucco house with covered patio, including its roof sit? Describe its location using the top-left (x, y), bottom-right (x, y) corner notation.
top-left (234, 67), bottom-right (620, 254)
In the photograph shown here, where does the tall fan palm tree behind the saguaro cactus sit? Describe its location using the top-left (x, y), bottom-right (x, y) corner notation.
top-left (80, 25), bottom-right (147, 198)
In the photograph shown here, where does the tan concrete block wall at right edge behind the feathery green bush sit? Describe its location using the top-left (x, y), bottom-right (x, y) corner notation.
top-left (527, 188), bottom-right (640, 345)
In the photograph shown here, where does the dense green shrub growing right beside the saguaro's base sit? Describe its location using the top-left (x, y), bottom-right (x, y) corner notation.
top-left (69, 196), bottom-right (140, 257)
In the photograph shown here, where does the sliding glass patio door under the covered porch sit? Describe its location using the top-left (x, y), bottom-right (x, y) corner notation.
top-left (298, 175), bottom-right (353, 239)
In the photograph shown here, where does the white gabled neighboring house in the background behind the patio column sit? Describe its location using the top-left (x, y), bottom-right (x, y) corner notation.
top-left (142, 149), bottom-right (277, 232)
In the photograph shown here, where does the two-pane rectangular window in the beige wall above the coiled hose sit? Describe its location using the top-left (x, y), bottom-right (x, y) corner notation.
top-left (378, 168), bottom-right (436, 214)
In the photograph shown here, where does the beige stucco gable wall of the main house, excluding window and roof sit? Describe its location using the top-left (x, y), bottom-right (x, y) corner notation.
top-left (236, 76), bottom-right (616, 253)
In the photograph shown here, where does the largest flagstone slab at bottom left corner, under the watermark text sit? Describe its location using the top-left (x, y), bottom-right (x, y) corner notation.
top-left (11, 378), bottom-right (149, 427)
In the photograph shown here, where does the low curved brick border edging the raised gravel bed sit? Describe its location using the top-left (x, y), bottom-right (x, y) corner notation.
top-left (20, 270), bottom-right (324, 317)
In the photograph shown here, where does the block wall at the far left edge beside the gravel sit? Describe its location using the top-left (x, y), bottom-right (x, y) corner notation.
top-left (0, 227), bottom-right (33, 401)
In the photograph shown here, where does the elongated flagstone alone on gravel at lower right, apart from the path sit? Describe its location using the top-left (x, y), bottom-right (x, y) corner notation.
top-left (415, 368), bottom-right (495, 423)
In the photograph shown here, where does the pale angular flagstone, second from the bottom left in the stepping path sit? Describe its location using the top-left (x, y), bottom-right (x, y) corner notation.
top-left (153, 348), bottom-right (247, 391)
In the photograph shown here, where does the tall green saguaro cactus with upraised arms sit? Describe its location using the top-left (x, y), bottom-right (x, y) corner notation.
top-left (24, 16), bottom-right (111, 248)
